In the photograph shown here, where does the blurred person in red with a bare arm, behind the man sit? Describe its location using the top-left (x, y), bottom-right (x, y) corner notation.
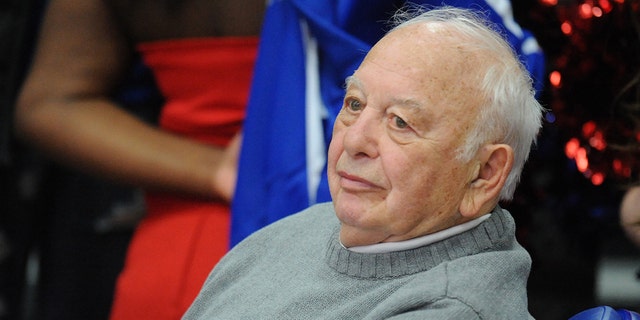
top-left (15, 0), bottom-right (265, 319)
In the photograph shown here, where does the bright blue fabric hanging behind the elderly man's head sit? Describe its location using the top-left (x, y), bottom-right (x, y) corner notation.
top-left (231, 0), bottom-right (544, 246)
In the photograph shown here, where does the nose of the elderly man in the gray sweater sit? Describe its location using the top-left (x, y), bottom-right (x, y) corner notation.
top-left (343, 108), bottom-right (383, 158)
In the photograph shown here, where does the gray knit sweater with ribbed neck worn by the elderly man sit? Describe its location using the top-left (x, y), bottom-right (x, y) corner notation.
top-left (183, 203), bottom-right (532, 320)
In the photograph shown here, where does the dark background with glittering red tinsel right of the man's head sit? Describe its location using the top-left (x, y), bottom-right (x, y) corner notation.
top-left (505, 0), bottom-right (640, 319)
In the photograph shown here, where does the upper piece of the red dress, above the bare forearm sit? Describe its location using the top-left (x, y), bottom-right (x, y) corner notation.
top-left (138, 38), bottom-right (258, 145)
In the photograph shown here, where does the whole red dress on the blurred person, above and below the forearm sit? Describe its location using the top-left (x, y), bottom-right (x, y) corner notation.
top-left (111, 37), bottom-right (258, 320)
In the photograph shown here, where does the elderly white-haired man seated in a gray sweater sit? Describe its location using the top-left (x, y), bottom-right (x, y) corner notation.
top-left (184, 8), bottom-right (542, 319)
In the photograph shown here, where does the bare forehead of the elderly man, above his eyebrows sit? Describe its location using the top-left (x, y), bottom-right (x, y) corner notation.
top-left (347, 22), bottom-right (482, 112)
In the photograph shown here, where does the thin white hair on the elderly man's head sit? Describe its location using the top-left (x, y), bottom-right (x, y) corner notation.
top-left (390, 7), bottom-right (544, 200)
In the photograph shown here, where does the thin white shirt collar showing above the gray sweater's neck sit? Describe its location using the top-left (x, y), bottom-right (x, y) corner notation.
top-left (341, 214), bottom-right (491, 253)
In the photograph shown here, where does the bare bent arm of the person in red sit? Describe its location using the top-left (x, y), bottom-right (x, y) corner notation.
top-left (16, 0), bottom-right (235, 200)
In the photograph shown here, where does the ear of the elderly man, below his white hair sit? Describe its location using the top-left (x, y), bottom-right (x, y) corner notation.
top-left (459, 144), bottom-right (513, 219)
